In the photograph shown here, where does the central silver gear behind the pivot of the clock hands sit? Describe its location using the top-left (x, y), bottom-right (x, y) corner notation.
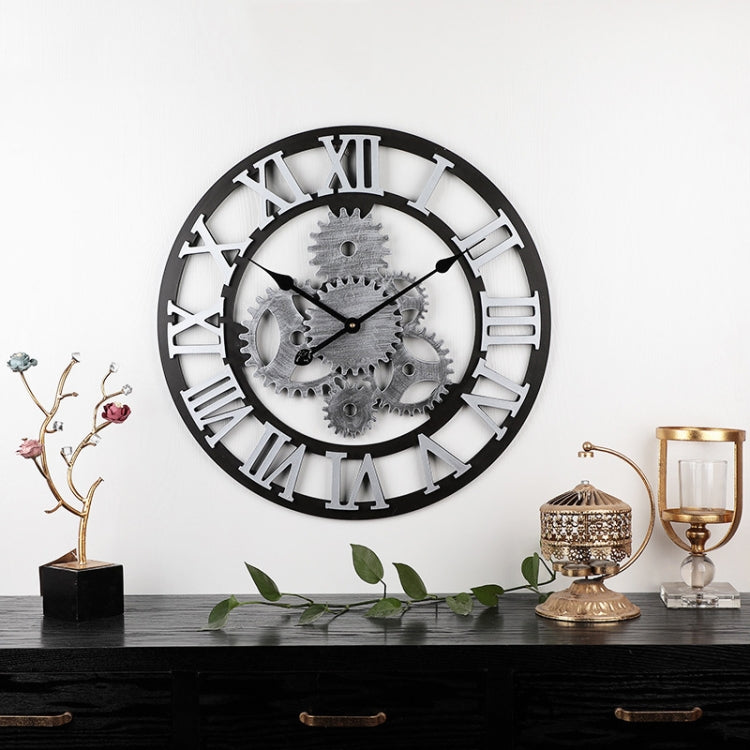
top-left (306, 277), bottom-right (401, 375)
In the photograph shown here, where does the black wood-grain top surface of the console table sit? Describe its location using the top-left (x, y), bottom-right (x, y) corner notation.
top-left (0, 593), bottom-right (750, 652)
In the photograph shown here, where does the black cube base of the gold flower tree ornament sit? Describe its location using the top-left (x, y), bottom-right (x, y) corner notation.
top-left (39, 563), bottom-right (124, 621)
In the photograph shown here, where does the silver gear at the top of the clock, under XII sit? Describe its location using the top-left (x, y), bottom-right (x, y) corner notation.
top-left (308, 208), bottom-right (391, 279)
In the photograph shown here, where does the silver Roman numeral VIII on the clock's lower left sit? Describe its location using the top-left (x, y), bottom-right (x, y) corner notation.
top-left (180, 365), bottom-right (253, 448)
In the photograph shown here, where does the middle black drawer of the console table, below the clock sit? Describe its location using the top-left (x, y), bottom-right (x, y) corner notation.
top-left (199, 672), bottom-right (486, 750)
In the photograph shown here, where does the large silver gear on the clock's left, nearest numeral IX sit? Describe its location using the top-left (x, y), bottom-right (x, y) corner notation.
top-left (240, 289), bottom-right (335, 396)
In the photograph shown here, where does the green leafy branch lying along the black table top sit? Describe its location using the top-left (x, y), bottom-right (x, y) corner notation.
top-left (209, 544), bottom-right (556, 630)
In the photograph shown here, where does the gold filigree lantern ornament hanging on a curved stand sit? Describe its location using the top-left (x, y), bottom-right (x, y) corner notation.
top-left (536, 442), bottom-right (656, 622)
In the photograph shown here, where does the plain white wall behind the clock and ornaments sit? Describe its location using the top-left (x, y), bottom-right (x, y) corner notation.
top-left (0, 0), bottom-right (750, 594)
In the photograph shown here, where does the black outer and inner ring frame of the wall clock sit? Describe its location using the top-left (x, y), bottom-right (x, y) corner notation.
top-left (158, 125), bottom-right (550, 520)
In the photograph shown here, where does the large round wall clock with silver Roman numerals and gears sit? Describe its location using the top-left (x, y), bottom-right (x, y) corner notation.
top-left (158, 126), bottom-right (550, 519)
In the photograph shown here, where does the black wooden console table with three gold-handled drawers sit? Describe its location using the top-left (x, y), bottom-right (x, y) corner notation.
top-left (0, 594), bottom-right (750, 750)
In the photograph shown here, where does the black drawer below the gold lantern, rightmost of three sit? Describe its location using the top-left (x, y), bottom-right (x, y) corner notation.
top-left (514, 671), bottom-right (750, 750)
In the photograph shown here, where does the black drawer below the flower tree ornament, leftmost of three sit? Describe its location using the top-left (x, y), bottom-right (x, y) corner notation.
top-left (0, 673), bottom-right (172, 750)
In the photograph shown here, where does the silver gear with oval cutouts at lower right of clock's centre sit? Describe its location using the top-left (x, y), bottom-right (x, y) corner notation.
top-left (376, 326), bottom-right (453, 416)
